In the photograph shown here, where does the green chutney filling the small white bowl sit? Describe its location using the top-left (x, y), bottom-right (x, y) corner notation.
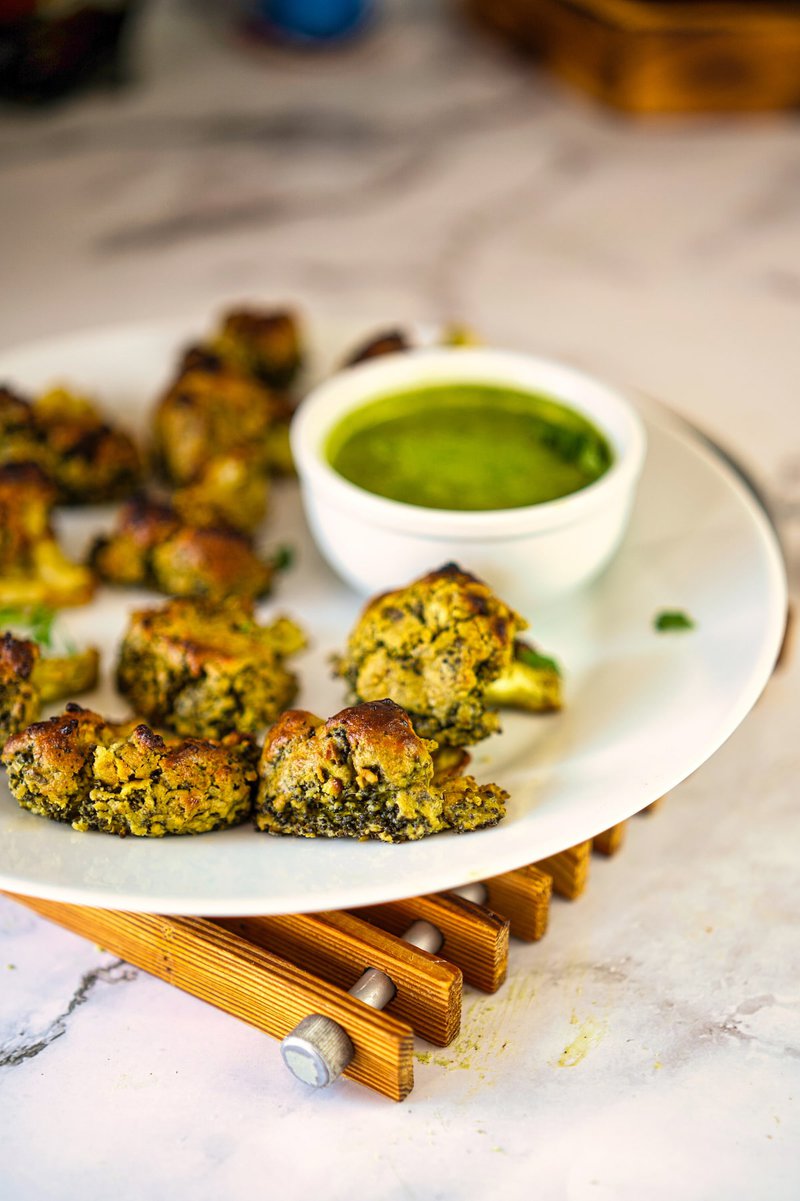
top-left (326, 383), bottom-right (613, 509)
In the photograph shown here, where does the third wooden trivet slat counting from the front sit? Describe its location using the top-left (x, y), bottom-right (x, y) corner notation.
top-left (354, 892), bottom-right (509, 992)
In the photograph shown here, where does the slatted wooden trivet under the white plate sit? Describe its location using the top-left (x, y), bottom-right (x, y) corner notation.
top-left (7, 802), bottom-right (653, 1101)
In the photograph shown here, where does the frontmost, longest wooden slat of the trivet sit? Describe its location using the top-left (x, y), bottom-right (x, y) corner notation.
top-left (8, 894), bottom-right (413, 1101)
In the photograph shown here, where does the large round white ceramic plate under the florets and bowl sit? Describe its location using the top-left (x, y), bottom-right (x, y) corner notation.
top-left (0, 317), bottom-right (786, 915)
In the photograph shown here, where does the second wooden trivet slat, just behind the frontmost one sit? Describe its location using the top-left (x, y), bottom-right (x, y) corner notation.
top-left (215, 913), bottom-right (462, 1046)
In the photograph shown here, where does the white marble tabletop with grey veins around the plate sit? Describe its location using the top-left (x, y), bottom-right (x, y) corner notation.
top-left (0, 0), bottom-right (800, 1201)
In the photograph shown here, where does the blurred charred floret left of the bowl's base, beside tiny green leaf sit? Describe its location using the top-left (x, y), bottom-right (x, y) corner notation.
top-left (91, 497), bottom-right (274, 601)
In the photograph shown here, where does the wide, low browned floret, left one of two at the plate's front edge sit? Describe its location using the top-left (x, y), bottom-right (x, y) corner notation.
top-left (2, 705), bottom-right (256, 837)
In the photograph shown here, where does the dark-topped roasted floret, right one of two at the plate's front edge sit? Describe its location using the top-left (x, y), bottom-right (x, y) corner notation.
top-left (256, 700), bottom-right (507, 842)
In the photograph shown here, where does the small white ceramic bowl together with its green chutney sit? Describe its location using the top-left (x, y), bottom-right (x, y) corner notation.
top-left (289, 347), bottom-right (646, 615)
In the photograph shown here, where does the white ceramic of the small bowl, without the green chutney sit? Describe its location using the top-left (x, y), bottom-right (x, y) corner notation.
top-left (291, 347), bottom-right (645, 613)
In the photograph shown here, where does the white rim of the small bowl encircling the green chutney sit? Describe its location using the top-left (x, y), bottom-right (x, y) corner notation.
top-left (289, 346), bottom-right (646, 538)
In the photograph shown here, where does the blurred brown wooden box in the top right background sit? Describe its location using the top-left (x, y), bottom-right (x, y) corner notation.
top-left (462, 0), bottom-right (800, 113)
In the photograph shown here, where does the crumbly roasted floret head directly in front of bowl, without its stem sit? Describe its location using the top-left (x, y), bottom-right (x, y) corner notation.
top-left (338, 563), bottom-right (526, 746)
